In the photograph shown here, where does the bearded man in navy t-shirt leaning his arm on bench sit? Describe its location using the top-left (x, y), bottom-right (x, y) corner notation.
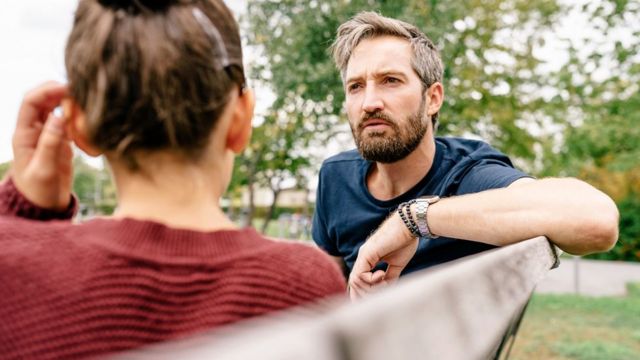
top-left (313, 12), bottom-right (618, 297)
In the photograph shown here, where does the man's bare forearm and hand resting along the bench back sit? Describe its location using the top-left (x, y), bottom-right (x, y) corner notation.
top-left (350, 178), bottom-right (618, 298)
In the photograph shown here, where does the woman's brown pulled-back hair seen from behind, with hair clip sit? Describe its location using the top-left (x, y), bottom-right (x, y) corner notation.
top-left (66, 0), bottom-right (244, 169)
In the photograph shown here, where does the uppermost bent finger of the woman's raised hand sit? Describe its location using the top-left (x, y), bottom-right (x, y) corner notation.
top-left (16, 81), bottom-right (67, 129)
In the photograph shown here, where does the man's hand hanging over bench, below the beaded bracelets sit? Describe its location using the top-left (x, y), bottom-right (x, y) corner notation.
top-left (349, 212), bottom-right (418, 300)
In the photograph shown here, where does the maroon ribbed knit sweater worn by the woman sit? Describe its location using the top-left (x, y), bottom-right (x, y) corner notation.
top-left (0, 181), bottom-right (345, 359)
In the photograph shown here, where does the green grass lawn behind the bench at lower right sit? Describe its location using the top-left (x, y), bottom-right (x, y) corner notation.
top-left (510, 284), bottom-right (640, 360)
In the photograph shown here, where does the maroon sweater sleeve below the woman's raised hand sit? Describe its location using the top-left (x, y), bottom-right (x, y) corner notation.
top-left (0, 178), bottom-right (78, 221)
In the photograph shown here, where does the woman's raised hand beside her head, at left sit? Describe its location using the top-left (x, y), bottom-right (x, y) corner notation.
top-left (11, 82), bottom-right (73, 210)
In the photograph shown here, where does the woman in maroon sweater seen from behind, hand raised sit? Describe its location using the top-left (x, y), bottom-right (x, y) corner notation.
top-left (0, 0), bottom-right (344, 359)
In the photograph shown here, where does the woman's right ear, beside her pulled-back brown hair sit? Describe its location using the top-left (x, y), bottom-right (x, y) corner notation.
top-left (226, 88), bottom-right (256, 154)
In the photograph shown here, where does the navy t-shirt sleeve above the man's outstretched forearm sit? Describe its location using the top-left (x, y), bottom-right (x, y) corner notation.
top-left (457, 159), bottom-right (531, 195)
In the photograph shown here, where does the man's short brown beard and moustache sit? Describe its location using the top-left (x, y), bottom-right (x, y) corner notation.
top-left (351, 96), bottom-right (428, 164)
